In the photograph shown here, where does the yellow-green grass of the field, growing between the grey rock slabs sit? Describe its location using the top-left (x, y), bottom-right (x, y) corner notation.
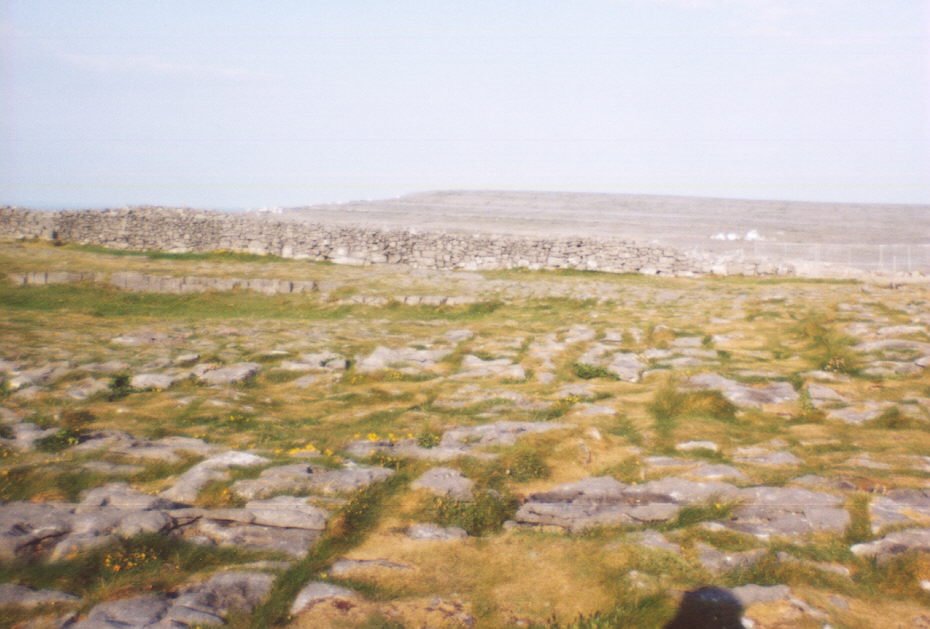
top-left (0, 244), bottom-right (930, 628)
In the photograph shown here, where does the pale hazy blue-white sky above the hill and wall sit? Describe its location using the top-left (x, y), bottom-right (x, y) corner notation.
top-left (0, 0), bottom-right (930, 209)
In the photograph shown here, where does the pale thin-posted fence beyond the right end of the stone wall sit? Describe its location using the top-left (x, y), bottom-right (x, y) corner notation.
top-left (691, 240), bottom-right (930, 273)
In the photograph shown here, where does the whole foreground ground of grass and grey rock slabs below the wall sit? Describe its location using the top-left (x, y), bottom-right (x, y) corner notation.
top-left (0, 244), bottom-right (930, 628)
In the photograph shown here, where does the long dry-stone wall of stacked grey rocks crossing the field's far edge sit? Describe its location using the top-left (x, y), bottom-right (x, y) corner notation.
top-left (0, 208), bottom-right (790, 275)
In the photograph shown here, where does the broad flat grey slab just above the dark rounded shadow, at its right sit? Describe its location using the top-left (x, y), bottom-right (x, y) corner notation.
top-left (722, 486), bottom-right (850, 539)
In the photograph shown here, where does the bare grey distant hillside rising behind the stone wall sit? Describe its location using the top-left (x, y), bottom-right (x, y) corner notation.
top-left (285, 190), bottom-right (930, 246)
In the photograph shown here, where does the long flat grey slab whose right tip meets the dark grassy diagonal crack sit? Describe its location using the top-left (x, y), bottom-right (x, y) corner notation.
top-left (232, 463), bottom-right (394, 499)
